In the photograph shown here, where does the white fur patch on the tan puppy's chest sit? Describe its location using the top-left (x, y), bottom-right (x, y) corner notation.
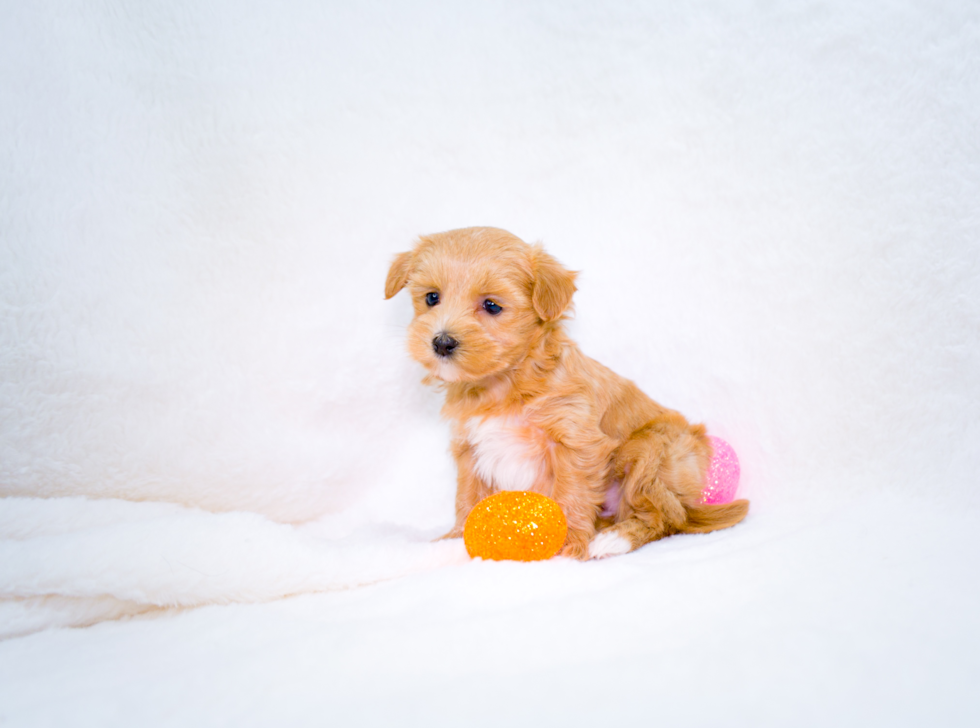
top-left (466, 416), bottom-right (549, 490)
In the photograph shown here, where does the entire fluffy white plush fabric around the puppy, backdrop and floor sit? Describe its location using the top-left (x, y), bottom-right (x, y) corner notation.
top-left (0, 0), bottom-right (980, 726)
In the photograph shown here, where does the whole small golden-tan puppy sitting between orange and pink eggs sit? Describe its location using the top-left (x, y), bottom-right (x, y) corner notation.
top-left (385, 227), bottom-right (749, 559)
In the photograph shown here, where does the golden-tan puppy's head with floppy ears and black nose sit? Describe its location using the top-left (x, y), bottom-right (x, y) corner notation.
top-left (385, 228), bottom-right (575, 382)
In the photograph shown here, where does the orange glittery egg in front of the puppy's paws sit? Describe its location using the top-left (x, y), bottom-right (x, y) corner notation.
top-left (463, 490), bottom-right (568, 561)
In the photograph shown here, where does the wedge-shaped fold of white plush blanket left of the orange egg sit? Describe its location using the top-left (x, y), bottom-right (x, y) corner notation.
top-left (0, 498), bottom-right (467, 637)
